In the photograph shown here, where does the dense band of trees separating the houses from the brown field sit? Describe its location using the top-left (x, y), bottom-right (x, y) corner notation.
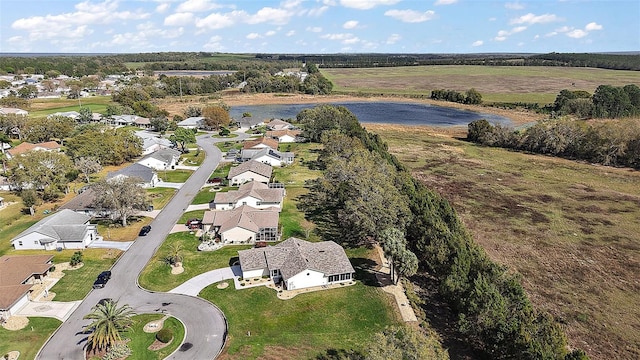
top-left (297, 105), bottom-right (586, 359)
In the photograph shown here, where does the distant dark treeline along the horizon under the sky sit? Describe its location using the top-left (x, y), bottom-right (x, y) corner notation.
top-left (0, 52), bottom-right (640, 77)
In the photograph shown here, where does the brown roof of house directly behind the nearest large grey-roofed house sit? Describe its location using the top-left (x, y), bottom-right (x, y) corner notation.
top-left (202, 205), bottom-right (279, 233)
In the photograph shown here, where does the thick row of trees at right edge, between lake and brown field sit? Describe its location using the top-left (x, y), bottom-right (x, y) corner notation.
top-left (467, 119), bottom-right (640, 169)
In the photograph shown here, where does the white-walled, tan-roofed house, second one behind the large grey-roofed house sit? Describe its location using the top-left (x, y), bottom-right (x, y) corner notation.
top-left (210, 181), bottom-right (285, 210)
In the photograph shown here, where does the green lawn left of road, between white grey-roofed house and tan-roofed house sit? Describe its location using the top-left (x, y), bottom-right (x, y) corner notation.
top-left (48, 249), bottom-right (122, 301)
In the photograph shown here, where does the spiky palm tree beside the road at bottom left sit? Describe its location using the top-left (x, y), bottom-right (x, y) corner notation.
top-left (84, 300), bottom-right (135, 351)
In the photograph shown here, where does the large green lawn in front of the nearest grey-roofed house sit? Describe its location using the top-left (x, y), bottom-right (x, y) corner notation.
top-left (199, 251), bottom-right (398, 359)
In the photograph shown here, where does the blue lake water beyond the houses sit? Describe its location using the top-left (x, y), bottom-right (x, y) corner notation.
top-left (230, 102), bottom-right (511, 126)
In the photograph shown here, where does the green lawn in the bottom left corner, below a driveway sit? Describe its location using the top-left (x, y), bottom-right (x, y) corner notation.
top-left (0, 317), bottom-right (62, 359)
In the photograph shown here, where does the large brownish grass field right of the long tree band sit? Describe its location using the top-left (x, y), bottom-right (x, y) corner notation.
top-left (367, 124), bottom-right (640, 359)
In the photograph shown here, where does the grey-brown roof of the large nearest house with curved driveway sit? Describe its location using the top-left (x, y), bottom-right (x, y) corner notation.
top-left (238, 237), bottom-right (355, 281)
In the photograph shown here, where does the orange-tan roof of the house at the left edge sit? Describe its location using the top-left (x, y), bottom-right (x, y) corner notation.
top-left (0, 255), bottom-right (53, 310)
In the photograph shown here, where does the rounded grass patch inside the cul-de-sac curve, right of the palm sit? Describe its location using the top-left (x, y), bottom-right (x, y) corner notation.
top-left (123, 314), bottom-right (185, 360)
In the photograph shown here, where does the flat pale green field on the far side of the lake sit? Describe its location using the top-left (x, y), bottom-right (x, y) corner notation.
top-left (322, 65), bottom-right (640, 104)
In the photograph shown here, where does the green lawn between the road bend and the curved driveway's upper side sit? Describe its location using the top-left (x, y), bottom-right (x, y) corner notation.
top-left (138, 232), bottom-right (251, 291)
